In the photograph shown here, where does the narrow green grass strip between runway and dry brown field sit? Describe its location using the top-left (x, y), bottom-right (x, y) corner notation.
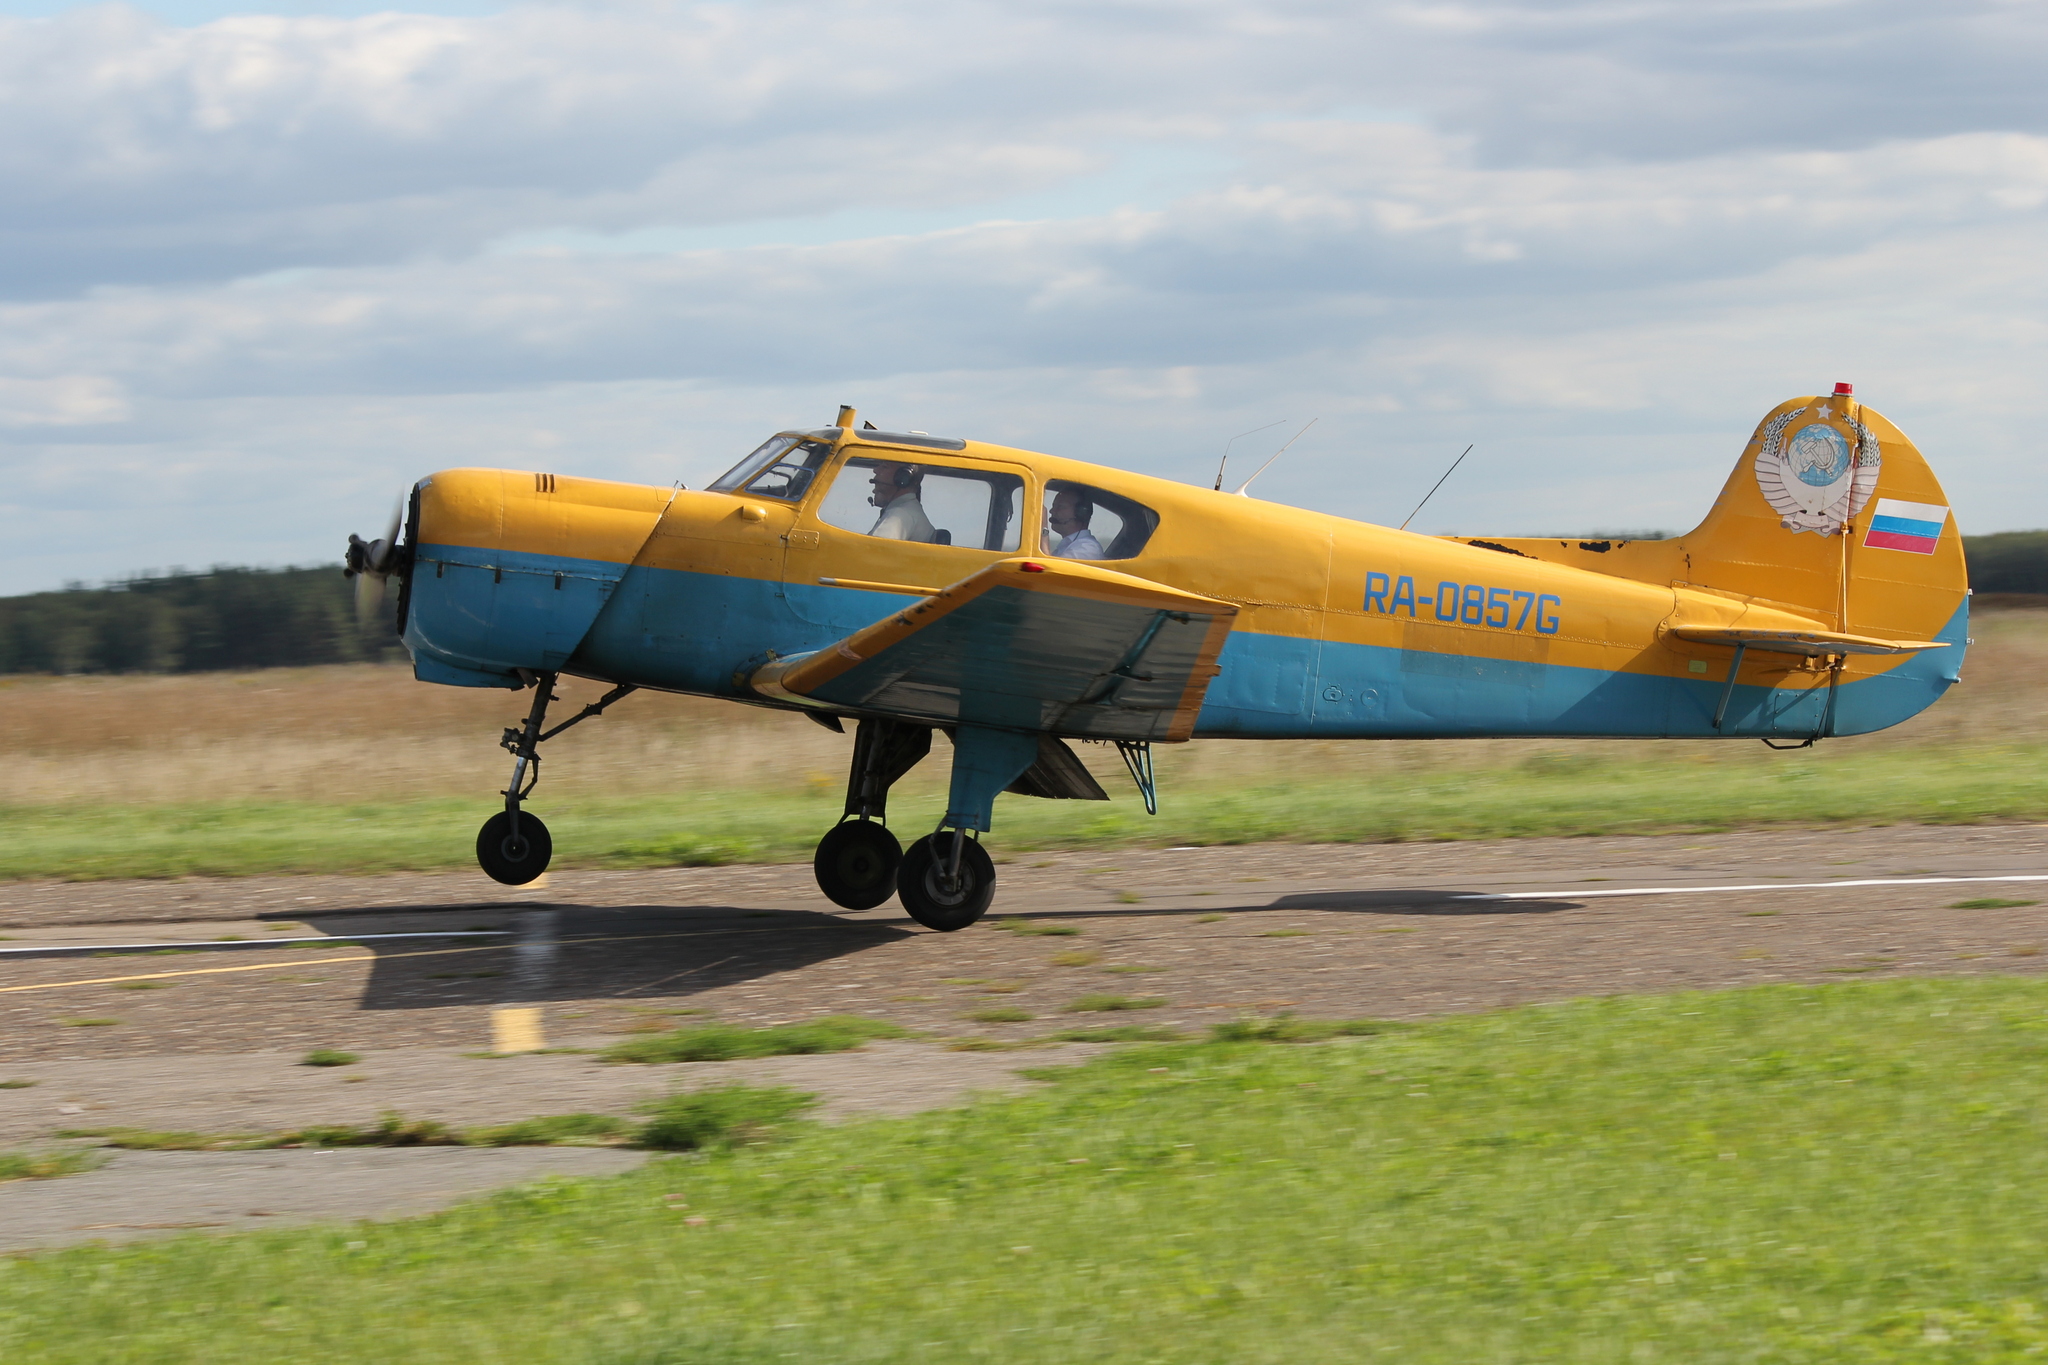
top-left (12, 743), bottom-right (2048, 880)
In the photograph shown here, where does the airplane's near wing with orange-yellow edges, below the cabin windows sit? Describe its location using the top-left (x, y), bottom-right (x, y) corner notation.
top-left (750, 559), bottom-right (1237, 743)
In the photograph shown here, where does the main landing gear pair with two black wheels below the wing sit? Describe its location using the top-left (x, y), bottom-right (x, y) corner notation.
top-left (811, 720), bottom-right (1056, 933)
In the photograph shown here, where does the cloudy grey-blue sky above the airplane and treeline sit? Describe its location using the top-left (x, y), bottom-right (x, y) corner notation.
top-left (0, 0), bottom-right (2048, 593)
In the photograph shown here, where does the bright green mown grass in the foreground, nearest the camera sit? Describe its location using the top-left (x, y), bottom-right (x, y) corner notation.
top-left (0, 978), bottom-right (2048, 1365)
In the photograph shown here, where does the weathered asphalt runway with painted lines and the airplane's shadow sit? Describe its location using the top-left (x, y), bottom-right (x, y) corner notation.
top-left (0, 825), bottom-right (2048, 1244)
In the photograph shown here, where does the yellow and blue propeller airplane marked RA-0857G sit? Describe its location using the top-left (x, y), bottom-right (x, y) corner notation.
top-left (348, 385), bottom-right (1968, 929)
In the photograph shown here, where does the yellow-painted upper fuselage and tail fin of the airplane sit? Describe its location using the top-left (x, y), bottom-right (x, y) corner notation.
top-left (422, 397), bottom-right (1966, 688)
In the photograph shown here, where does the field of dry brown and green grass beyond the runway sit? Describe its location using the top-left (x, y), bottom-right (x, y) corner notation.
top-left (0, 610), bottom-right (2048, 876)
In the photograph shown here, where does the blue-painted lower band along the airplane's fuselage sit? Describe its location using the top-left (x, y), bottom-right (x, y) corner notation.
top-left (408, 551), bottom-right (1968, 739)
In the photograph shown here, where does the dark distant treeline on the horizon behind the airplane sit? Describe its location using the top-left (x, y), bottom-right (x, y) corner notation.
top-left (0, 530), bottom-right (2048, 673)
